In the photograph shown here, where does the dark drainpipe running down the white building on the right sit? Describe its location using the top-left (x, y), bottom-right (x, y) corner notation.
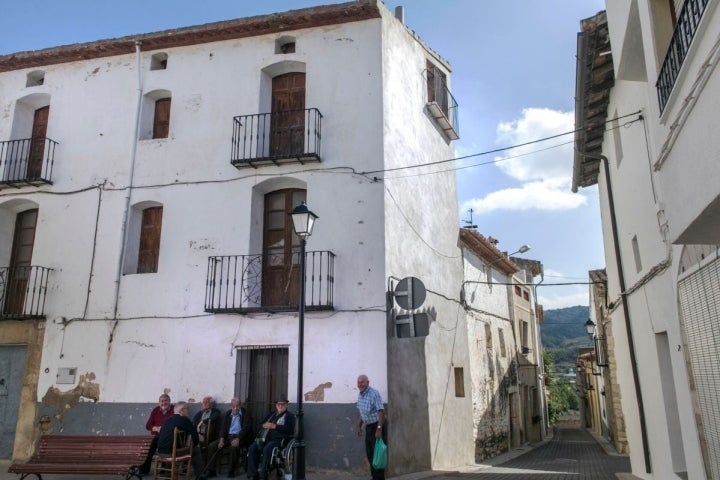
top-left (576, 150), bottom-right (652, 473)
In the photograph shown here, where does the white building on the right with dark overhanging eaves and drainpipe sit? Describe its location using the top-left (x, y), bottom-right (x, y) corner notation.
top-left (573, 0), bottom-right (720, 479)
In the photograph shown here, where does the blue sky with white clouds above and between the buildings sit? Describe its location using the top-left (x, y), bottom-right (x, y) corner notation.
top-left (0, 0), bottom-right (605, 309)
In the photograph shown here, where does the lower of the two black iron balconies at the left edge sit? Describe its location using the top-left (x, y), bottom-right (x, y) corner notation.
top-left (0, 266), bottom-right (51, 320)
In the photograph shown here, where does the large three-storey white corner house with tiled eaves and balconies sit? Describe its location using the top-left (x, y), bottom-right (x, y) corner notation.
top-left (0, 0), bottom-right (474, 473)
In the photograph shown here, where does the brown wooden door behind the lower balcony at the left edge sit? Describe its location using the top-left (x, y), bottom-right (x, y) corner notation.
top-left (3, 209), bottom-right (38, 315)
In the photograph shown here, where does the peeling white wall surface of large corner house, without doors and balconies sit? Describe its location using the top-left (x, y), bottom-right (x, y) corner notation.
top-left (0, 1), bottom-right (473, 473)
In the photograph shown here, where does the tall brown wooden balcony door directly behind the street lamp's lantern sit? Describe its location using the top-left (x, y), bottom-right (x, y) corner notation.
top-left (262, 189), bottom-right (305, 306)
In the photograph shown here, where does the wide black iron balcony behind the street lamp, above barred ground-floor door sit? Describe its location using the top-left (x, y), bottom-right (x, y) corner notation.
top-left (205, 251), bottom-right (335, 314)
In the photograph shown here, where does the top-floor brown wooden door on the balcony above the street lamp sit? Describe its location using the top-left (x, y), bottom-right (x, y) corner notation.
top-left (270, 72), bottom-right (305, 157)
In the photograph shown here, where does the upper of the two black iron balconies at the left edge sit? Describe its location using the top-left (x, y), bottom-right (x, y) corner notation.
top-left (0, 137), bottom-right (58, 188)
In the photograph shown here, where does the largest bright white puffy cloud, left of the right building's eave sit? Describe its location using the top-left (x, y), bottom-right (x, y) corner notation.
top-left (460, 108), bottom-right (587, 213)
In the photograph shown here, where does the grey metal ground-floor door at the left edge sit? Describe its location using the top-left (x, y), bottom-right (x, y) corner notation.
top-left (0, 345), bottom-right (27, 458)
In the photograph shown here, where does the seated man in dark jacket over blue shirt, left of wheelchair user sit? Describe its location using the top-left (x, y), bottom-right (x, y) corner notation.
top-left (207, 398), bottom-right (253, 478)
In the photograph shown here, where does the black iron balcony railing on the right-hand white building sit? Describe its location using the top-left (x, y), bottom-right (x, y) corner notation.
top-left (655, 0), bottom-right (709, 113)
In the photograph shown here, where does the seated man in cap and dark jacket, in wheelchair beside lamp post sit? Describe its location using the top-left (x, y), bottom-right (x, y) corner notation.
top-left (247, 397), bottom-right (295, 480)
